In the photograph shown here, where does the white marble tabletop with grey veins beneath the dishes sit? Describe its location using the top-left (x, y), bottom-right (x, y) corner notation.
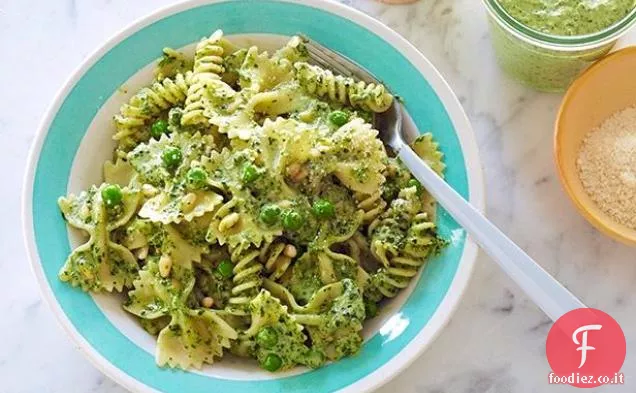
top-left (0, 0), bottom-right (636, 393)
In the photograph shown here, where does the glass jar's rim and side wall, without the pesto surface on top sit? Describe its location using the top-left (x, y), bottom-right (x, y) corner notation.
top-left (482, 0), bottom-right (636, 92)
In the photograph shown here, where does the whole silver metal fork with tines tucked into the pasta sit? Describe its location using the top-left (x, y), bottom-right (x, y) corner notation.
top-left (303, 37), bottom-right (586, 321)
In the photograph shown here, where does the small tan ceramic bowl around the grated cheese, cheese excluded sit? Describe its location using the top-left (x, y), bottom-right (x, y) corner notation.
top-left (554, 47), bottom-right (636, 245)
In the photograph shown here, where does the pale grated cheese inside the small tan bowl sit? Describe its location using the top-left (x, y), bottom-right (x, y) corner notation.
top-left (577, 107), bottom-right (636, 229)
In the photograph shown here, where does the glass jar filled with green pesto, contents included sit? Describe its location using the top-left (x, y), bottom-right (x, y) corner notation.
top-left (482, 0), bottom-right (636, 92)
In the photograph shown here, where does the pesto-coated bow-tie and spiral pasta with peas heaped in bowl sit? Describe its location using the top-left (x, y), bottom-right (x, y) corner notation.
top-left (58, 30), bottom-right (445, 372)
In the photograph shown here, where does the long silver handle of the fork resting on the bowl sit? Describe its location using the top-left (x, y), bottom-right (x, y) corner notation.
top-left (398, 144), bottom-right (585, 321)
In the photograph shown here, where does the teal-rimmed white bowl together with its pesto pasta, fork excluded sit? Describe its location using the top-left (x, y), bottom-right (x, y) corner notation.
top-left (23, 0), bottom-right (484, 393)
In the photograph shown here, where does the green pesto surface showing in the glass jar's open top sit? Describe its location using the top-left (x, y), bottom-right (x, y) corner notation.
top-left (498, 0), bottom-right (636, 36)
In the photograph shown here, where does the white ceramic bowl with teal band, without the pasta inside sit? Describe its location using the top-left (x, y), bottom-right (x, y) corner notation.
top-left (23, 0), bottom-right (484, 393)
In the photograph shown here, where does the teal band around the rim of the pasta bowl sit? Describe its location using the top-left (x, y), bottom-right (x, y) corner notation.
top-left (25, 0), bottom-right (469, 393)
